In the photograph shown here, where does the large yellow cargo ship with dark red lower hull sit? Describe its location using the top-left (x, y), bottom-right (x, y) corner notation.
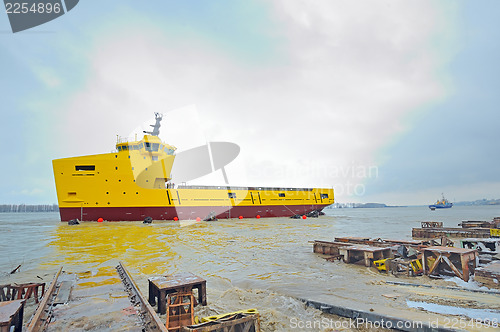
top-left (52, 113), bottom-right (334, 221)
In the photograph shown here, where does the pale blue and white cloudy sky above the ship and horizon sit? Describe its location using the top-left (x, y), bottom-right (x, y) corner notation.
top-left (0, 0), bottom-right (500, 205)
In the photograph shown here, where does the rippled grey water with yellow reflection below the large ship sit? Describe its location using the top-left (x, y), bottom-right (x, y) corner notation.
top-left (0, 206), bottom-right (500, 331)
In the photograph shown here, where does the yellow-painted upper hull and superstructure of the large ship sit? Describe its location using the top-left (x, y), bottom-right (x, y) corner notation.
top-left (52, 135), bottom-right (334, 220)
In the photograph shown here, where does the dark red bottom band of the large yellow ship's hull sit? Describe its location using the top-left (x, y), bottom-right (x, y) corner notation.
top-left (59, 204), bottom-right (328, 221)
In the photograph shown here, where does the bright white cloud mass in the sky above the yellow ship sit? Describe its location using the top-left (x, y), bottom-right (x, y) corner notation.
top-left (55, 0), bottom-right (445, 201)
